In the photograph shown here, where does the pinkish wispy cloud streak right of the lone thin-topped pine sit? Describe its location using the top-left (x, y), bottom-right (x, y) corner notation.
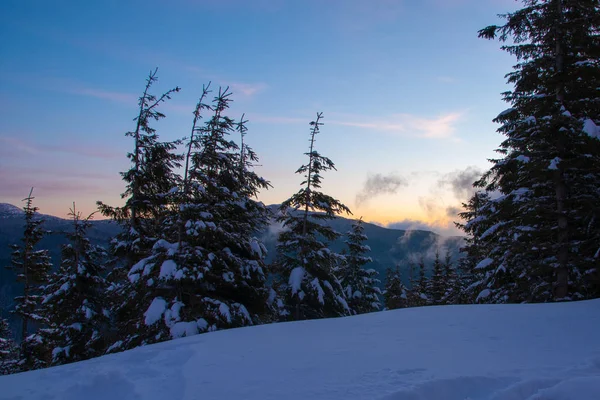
top-left (328, 112), bottom-right (464, 139)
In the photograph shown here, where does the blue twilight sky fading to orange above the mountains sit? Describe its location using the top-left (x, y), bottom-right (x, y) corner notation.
top-left (0, 0), bottom-right (519, 234)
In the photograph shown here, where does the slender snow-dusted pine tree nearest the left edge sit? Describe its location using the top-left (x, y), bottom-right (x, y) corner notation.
top-left (8, 188), bottom-right (52, 371)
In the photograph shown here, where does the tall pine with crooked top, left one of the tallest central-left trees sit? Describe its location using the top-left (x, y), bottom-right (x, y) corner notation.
top-left (97, 69), bottom-right (183, 351)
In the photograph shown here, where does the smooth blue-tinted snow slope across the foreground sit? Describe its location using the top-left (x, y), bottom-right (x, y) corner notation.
top-left (0, 300), bottom-right (600, 400)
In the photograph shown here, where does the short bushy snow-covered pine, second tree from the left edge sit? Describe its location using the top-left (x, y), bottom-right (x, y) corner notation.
top-left (40, 203), bottom-right (109, 365)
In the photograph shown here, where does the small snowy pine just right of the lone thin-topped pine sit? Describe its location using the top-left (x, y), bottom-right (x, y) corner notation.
top-left (341, 218), bottom-right (381, 314)
